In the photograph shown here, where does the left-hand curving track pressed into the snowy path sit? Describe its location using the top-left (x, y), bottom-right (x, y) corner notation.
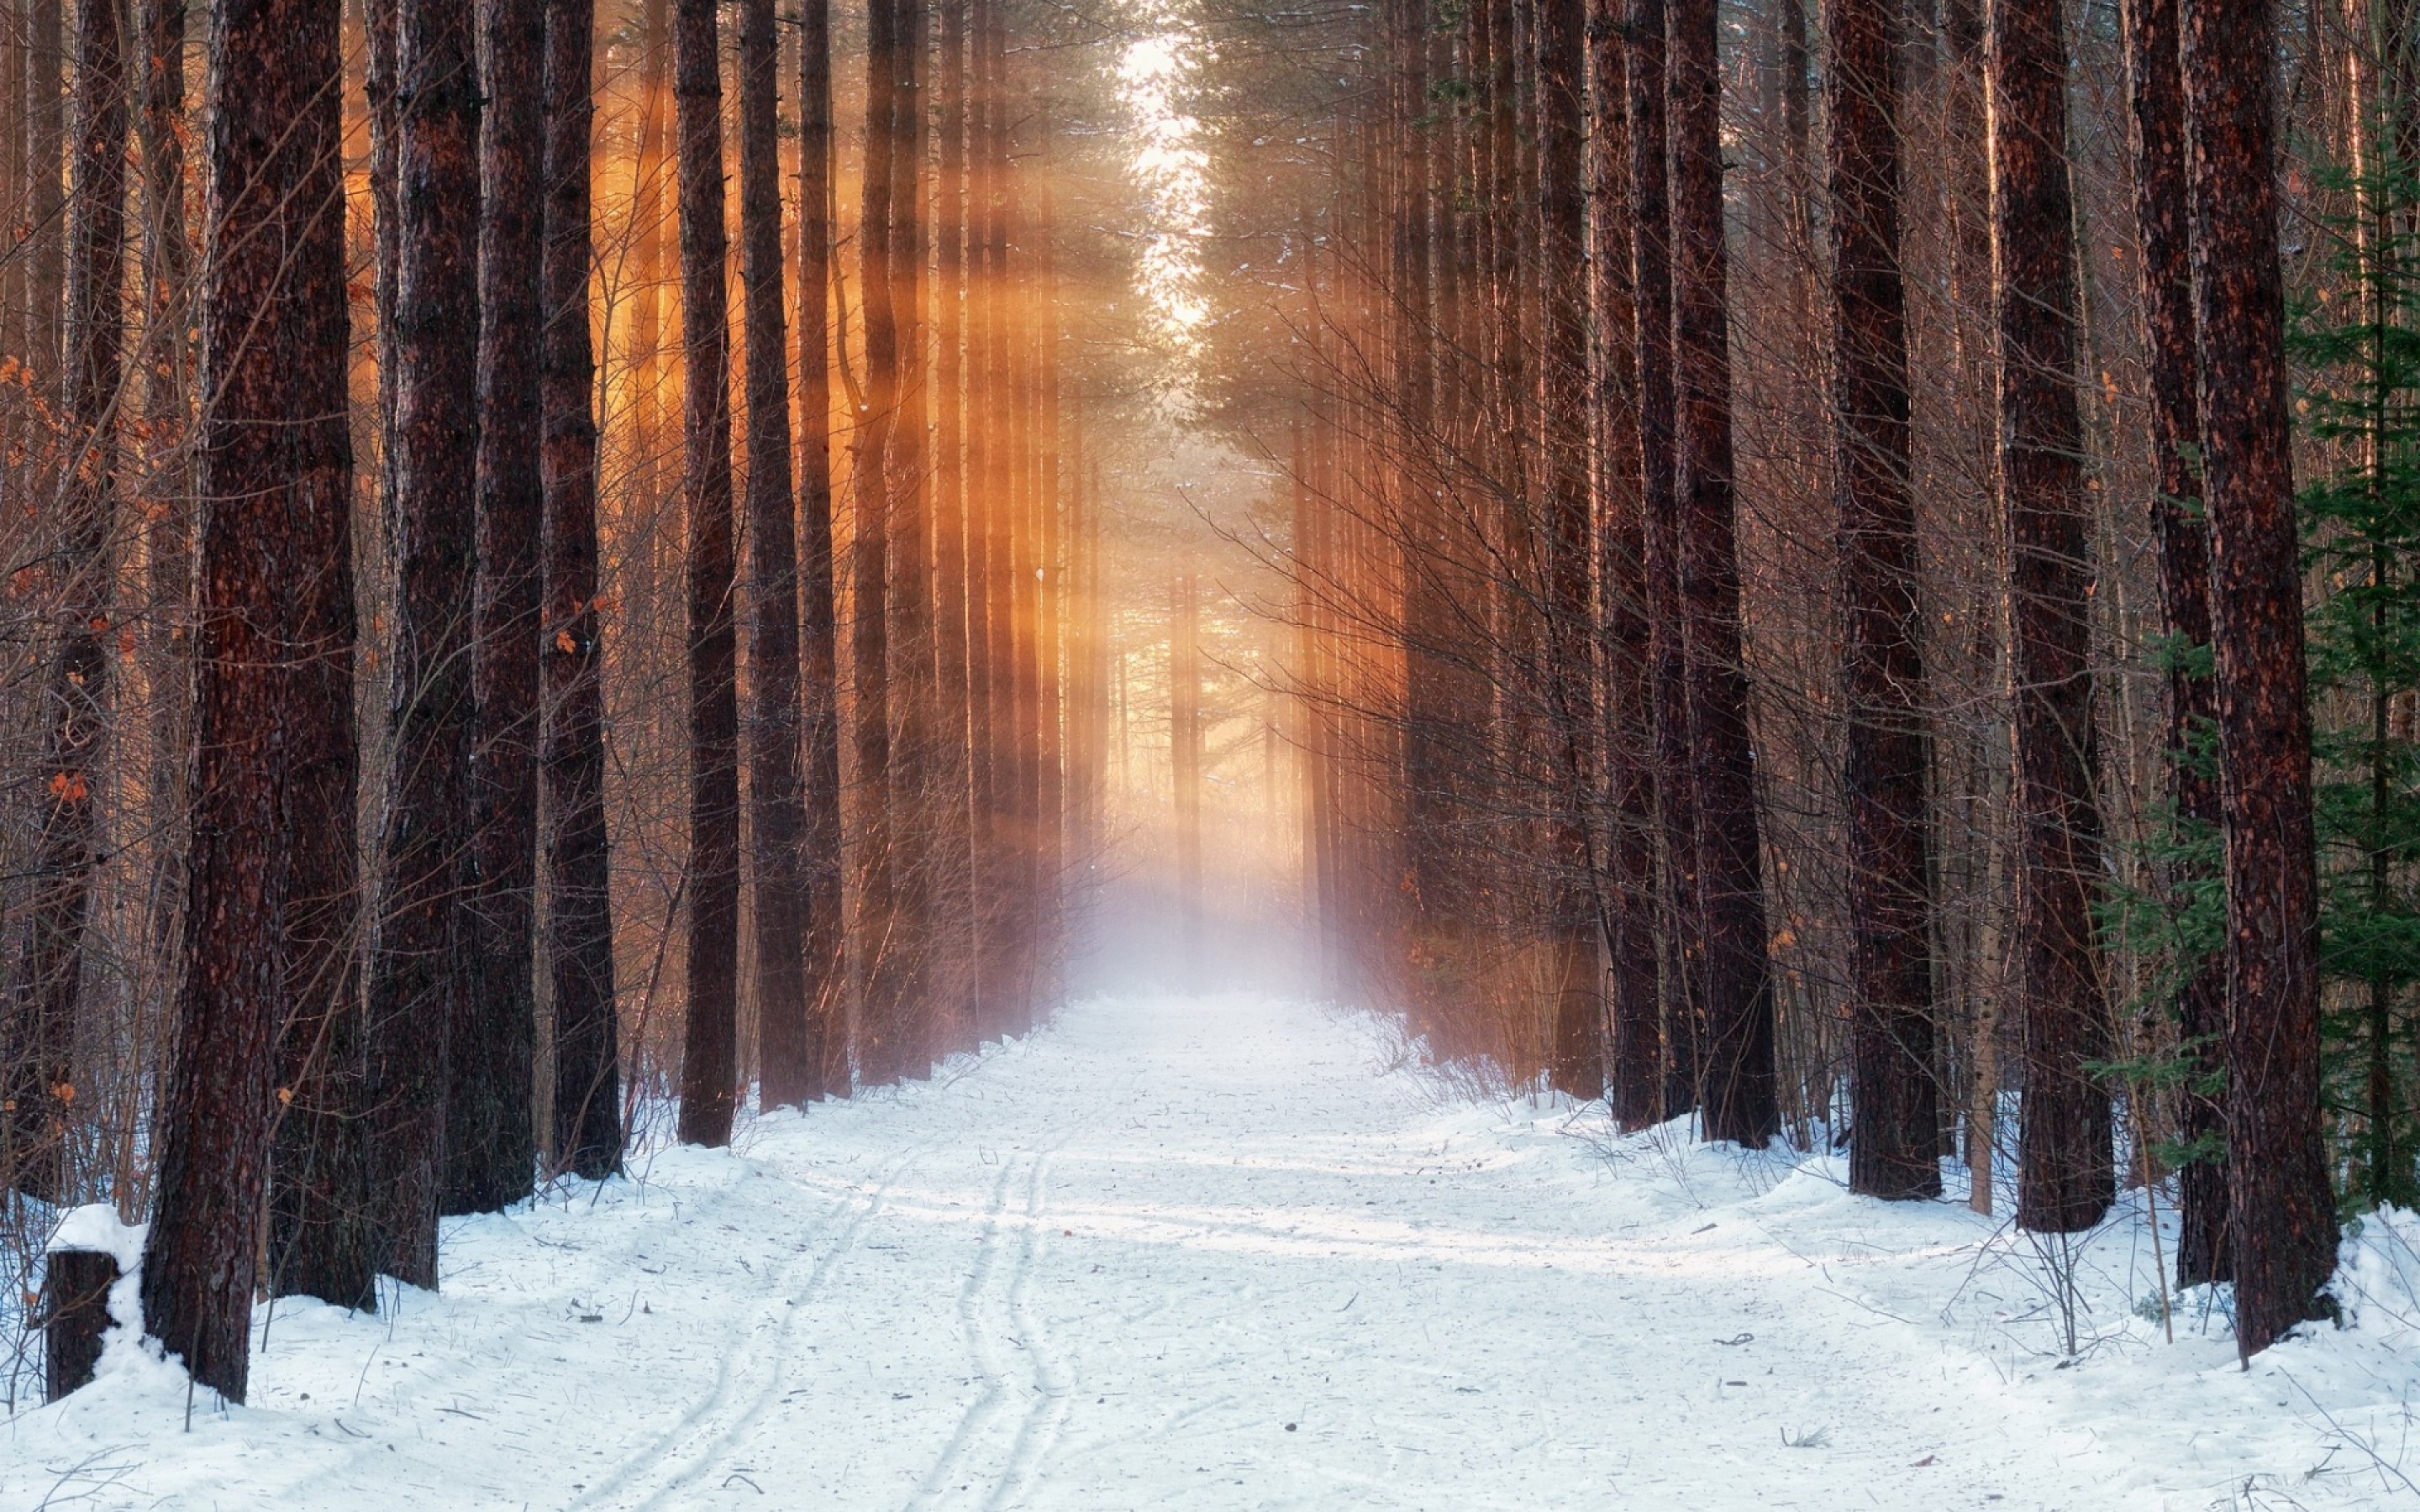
top-left (571, 1139), bottom-right (939, 1512)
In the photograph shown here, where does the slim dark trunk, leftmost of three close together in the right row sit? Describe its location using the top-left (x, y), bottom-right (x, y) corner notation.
top-left (1587, 0), bottom-right (1663, 1130)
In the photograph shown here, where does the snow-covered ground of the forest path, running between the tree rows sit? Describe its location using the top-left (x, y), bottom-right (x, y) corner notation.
top-left (0, 997), bottom-right (2420, 1512)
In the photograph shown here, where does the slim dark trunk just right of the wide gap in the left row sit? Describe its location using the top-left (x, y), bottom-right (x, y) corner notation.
top-left (673, 0), bottom-right (740, 1144)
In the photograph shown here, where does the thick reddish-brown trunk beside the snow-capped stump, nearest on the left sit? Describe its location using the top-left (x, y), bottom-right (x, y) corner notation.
top-left (143, 0), bottom-right (351, 1401)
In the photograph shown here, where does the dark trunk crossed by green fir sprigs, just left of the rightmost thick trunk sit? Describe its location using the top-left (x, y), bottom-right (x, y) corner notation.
top-left (2125, 0), bottom-right (2231, 1287)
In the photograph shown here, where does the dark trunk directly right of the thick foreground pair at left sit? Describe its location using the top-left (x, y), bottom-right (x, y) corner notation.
top-left (371, 0), bottom-right (479, 1287)
